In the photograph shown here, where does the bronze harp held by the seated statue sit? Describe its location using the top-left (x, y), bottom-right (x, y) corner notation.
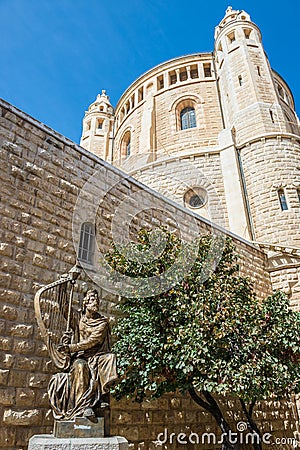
top-left (34, 265), bottom-right (81, 370)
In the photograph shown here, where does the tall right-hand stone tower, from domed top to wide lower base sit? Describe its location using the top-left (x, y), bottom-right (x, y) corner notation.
top-left (215, 8), bottom-right (300, 302)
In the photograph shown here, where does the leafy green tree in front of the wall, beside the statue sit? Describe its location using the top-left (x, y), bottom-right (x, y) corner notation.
top-left (107, 230), bottom-right (300, 450)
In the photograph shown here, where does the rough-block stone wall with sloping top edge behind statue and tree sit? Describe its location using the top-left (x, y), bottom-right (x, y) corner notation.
top-left (0, 101), bottom-right (294, 450)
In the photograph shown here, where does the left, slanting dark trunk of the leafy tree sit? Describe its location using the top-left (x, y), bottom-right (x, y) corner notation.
top-left (189, 386), bottom-right (240, 450)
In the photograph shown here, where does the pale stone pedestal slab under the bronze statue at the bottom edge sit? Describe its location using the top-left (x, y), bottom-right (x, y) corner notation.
top-left (28, 434), bottom-right (128, 450)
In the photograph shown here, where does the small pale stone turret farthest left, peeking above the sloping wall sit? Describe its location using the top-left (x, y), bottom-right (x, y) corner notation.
top-left (80, 90), bottom-right (114, 162)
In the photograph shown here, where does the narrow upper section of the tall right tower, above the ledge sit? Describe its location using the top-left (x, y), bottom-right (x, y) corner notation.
top-left (215, 7), bottom-right (295, 144)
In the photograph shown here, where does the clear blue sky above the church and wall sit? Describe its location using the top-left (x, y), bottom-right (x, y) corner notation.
top-left (0, 0), bottom-right (300, 142)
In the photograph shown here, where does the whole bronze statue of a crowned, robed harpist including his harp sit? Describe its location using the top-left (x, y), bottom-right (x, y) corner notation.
top-left (35, 269), bottom-right (117, 421)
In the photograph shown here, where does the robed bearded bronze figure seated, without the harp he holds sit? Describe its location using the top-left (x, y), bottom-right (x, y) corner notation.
top-left (48, 290), bottom-right (117, 421)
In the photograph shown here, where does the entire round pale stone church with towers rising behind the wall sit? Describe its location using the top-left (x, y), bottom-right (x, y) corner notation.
top-left (81, 7), bottom-right (300, 306)
